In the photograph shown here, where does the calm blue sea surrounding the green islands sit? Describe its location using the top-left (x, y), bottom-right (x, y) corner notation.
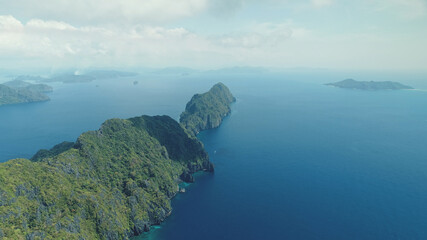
top-left (0, 71), bottom-right (427, 240)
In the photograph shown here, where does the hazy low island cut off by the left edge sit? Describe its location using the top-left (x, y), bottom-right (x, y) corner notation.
top-left (0, 80), bottom-right (53, 106)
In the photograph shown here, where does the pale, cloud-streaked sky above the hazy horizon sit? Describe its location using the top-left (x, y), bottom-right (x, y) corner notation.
top-left (0, 0), bottom-right (427, 70)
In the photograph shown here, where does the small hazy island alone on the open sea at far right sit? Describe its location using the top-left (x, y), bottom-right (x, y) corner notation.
top-left (325, 79), bottom-right (413, 90)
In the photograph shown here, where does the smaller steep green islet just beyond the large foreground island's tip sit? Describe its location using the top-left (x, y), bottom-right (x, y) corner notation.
top-left (180, 83), bottom-right (236, 135)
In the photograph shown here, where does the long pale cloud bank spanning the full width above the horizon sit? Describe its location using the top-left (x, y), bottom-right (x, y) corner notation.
top-left (0, 8), bottom-right (427, 69)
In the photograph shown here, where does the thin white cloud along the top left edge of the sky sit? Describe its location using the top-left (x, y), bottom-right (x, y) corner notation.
top-left (0, 0), bottom-right (208, 24)
